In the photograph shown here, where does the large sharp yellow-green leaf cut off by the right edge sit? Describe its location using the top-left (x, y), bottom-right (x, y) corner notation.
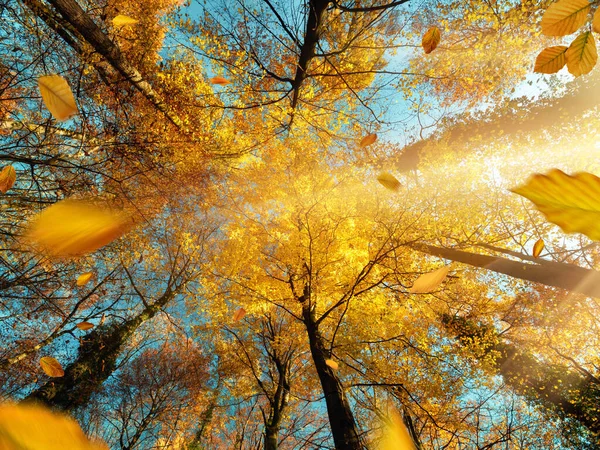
top-left (511, 169), bottom-right (600, 241)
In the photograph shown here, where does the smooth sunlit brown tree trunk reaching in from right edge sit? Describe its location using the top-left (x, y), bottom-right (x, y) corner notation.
top-left (411, 244), bottom-right (600, 297)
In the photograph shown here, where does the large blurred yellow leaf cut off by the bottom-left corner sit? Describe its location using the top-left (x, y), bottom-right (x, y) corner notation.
top-left (0, 403), bottom-right (108, 450)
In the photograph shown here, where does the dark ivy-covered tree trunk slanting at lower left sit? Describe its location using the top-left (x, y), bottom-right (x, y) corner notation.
top-left (25, 289), bottom-right (176, 411)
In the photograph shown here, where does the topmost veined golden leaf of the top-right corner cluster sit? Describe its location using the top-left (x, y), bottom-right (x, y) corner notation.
top-left (542, 0), bottom-right (591, 36)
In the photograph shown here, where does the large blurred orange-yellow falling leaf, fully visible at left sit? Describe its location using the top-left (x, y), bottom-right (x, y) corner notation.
top-left (26, 199), bottom-right (133, 258)
